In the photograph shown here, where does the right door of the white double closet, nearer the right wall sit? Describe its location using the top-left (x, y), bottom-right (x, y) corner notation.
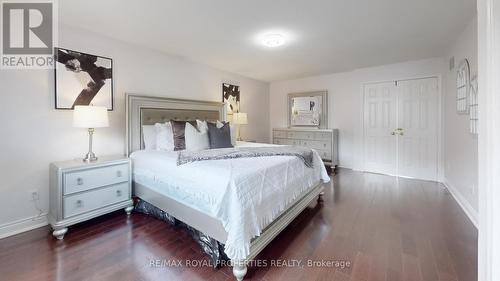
top-left (396, 78), bottom-right (438, 180)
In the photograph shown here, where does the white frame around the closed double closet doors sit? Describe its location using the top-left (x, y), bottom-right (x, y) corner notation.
top-left (359, 74), bottom-right (444, 182)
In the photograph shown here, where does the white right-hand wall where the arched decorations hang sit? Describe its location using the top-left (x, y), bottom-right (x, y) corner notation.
top-left (444, 19), bottom-right (478, 217)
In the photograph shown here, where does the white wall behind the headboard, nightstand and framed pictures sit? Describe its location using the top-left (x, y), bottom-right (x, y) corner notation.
top-left (0, 26), bottom-right (269, 236)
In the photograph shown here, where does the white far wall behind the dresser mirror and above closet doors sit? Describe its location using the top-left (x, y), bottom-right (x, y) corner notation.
top-left (270, 58), bottom-right (444, 170)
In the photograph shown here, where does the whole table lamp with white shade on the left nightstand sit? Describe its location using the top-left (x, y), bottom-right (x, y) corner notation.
top-left (73, 105), bottom-right (109, 163)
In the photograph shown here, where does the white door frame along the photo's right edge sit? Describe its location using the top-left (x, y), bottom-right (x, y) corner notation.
top-left (477, 0), bottom-right (500, 281)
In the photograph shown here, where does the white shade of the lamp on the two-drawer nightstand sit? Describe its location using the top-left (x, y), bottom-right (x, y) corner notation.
top-left (73, 105), bottom-right (109, 128)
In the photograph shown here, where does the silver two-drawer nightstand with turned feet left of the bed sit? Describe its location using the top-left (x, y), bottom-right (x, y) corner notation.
top-left (49, 156), bottom-right (133, 240)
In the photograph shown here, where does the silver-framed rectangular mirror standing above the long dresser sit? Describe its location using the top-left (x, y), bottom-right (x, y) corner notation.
top-left (288, 91), bottom-right (328, 129)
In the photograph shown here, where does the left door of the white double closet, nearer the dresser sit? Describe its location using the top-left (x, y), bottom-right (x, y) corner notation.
top-left (364, 82), bottom-right (397, 175)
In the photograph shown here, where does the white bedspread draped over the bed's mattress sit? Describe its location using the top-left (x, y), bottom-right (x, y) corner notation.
top-left (130, 142), bottom-right (330, 259)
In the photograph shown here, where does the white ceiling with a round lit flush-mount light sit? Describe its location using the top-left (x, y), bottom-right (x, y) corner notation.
top-left (59, 0), bottom-right (476, 81)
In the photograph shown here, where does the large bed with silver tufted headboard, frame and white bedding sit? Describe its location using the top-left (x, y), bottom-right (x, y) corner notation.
top-left (126, 94), bottom-right (330, 280)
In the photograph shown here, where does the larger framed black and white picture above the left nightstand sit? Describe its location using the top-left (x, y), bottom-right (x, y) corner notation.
top-left (55, 48), bottom-right (113, 110)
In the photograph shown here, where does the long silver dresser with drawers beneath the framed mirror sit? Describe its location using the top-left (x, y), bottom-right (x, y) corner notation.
top-left (273, 128), bottom-right (339, 168)
